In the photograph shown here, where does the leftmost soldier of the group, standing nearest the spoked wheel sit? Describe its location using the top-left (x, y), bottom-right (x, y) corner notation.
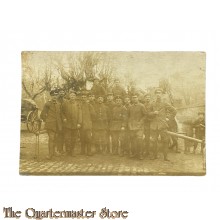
top-left (40, 90), bottom-right (62, 159)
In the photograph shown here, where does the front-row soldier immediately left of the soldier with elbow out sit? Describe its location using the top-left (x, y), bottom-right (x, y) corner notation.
top-left (128, 94), bottom-right (147, 160)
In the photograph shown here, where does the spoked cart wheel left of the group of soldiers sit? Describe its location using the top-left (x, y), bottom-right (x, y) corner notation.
top-left (27, 109), bottom-right (41, 133)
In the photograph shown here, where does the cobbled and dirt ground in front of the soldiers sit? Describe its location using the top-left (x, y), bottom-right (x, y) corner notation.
top-left (20, 131), bottom-right (205, 175)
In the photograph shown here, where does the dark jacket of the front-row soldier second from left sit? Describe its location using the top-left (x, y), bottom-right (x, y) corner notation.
top-left (62, 100), bottom-right (82, 129)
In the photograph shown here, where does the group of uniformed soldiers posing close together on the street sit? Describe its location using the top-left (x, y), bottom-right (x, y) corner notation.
top-left (41, 80), bottom-right (186, 161)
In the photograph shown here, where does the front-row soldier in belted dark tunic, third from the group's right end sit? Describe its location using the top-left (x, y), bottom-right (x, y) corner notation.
top-left (109, 96), bottom-right (127, 156)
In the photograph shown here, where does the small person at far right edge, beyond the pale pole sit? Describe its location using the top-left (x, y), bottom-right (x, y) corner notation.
top-left (193, 112), bottom-right (205, 154)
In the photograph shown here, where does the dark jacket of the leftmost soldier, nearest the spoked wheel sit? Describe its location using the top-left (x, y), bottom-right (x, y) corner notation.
top-left (40, 100), bottom-right (62, 131)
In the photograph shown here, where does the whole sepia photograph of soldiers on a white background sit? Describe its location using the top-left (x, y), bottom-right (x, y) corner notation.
top-left (19, 51), bottom-right (206, 176)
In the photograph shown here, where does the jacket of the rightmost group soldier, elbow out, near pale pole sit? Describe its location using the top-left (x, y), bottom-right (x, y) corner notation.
top-left (148, 101), bottom-right (176, 130)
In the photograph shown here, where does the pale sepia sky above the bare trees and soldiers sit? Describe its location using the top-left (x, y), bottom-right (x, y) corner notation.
top-left (24, 52), bottom-right (205, 89)
